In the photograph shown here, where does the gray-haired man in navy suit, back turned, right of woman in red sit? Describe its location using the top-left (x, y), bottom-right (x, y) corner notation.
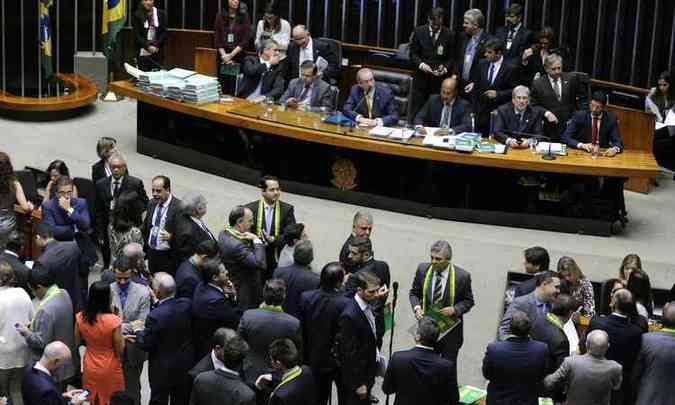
top-left (136, 272), bottom-right (194, 405)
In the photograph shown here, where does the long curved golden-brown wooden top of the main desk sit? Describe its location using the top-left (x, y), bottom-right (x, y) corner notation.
top-left (110, 81), bottom-right (660, 177)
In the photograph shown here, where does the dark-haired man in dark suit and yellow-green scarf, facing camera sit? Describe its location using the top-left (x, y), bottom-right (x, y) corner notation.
top-left (245, 176), bottom-right (295, 283)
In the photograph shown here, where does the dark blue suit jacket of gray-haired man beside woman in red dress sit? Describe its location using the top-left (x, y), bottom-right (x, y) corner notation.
top-left (136, 297), bottom-right (195, 390)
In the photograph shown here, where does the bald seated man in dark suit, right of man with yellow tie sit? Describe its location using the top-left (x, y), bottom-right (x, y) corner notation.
top-left (415, 77), bottom-right (473, 133)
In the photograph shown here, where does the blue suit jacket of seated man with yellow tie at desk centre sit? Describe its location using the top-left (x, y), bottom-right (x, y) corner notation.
top-left (342, 83), bottom-right (398, 126)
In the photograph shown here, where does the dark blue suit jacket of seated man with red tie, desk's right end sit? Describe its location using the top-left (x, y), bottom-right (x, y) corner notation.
top-left (561, 111), bottom-right (623, 150)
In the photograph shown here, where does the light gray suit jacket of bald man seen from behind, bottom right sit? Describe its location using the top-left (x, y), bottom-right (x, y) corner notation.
top-left (544, 354), bottom-right (623, 405)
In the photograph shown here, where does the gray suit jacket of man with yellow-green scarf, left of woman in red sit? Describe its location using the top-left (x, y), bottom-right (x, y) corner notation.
top-left (26, 289), bottom-right (80, 382)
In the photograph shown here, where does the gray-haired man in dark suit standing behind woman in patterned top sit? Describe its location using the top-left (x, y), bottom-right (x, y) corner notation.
top-left (95, 154), bottom-right (149, 269)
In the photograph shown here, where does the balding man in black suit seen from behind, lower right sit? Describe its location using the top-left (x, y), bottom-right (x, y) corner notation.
top-left (586, 289), bottom-right (643, 405)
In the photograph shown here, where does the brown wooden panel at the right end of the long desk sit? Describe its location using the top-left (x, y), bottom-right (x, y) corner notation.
top-left (607, 104), bottom-right (655, 193)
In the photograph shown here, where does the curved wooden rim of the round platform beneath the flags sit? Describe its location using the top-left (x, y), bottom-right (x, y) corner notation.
top-left (0, 73), bottom-right (98, 111)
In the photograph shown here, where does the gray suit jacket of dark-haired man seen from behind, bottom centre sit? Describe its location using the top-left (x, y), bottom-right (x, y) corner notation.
top-left (238, 308), bottom-right (302, 383)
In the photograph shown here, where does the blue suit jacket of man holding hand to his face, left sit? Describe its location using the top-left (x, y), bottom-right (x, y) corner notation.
top-left (42, 198), bottom-right (91, 240)
